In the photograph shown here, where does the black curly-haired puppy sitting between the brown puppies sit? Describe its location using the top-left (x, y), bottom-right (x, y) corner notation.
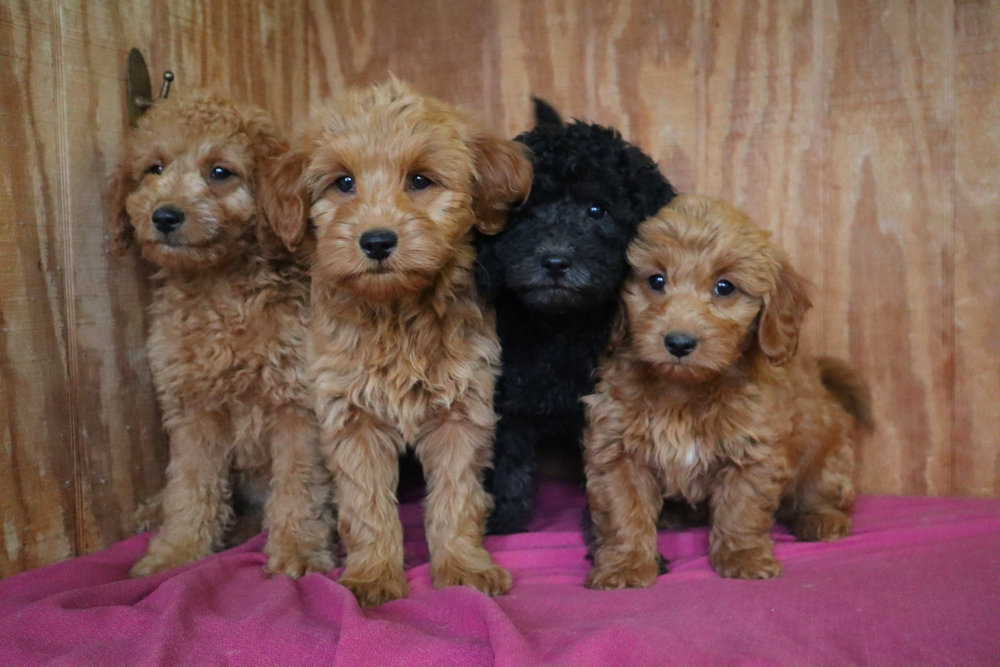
top-left (477, 99), bottom-right (675, 534)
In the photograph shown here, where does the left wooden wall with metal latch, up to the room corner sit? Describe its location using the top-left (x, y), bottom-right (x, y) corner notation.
top-left (0, 0), bottom-right (309, 576)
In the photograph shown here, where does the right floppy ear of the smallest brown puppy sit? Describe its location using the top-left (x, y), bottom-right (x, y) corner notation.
top-left (757, 260), bottom-right (812, 366)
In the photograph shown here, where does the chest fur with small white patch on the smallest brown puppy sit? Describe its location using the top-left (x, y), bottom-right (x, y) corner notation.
top-left (608, 360), bottom-right (794, 502)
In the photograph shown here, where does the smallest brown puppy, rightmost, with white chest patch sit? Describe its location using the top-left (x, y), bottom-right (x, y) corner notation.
top-left (584, 196), bottom-right (871, 589)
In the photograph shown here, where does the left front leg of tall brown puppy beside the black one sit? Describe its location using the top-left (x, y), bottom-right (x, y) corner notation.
top-left (321, 410), bottom-right (410, 607)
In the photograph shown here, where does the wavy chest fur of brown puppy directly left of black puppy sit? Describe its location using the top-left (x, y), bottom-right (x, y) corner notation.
top-left (311, 290), bottom-right (500, 443)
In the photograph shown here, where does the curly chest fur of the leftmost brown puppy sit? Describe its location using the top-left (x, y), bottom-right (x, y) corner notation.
top-left (149, 260), bottom-right (309, 422)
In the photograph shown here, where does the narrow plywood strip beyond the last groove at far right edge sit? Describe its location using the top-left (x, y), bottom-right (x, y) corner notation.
top-left (952, 0), bottom-right (1000, 496)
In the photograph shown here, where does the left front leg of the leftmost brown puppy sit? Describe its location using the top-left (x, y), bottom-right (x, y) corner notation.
top-left (129, 415), bottom-right (232, 577)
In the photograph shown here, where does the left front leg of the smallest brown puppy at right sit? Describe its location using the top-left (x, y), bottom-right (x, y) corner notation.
top-left (585, 454), bottom-right (665, 590)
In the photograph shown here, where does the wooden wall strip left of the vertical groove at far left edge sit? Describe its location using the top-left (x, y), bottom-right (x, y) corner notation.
top-left (0, 2), bottom-right (76, 577)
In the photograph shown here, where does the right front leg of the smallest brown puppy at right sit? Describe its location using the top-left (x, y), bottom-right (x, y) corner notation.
top-left (709, 463), bottom-right (787, 579)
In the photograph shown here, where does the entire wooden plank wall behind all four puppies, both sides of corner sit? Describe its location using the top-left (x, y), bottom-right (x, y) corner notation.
top-left (0, 0), bottom-right (1000, 576)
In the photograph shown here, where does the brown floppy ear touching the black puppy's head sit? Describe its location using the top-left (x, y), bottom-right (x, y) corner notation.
top-left (469, 134), bottom-right (532, 234)
